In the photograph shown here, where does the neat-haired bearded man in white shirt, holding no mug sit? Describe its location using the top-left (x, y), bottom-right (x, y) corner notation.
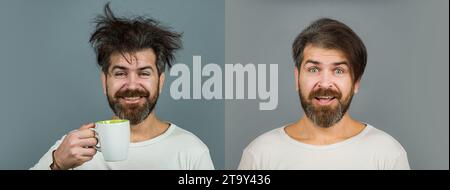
top-left (239, 18), bottom-right (410, 170)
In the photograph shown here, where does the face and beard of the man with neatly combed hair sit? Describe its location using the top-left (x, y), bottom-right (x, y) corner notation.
top-left (295, 45), bottom-right (359, 128)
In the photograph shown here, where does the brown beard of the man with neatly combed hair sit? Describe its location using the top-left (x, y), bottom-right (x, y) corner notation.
top-left (299, 87), bottom-right (353, 128)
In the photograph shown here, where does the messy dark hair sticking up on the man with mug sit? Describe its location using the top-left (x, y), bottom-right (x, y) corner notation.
top-left (89, 3), bottom-right (181, 74)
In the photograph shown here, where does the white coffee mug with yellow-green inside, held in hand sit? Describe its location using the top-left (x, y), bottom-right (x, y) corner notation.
top-left (92, 120), bottom-right (130, 162)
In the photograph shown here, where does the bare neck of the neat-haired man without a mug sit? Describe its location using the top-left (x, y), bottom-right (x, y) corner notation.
top-left (285, 112), bottom-right (365, 145)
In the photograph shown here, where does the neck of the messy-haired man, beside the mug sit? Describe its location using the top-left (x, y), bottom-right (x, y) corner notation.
top-left (126, 111), bottom-right (169, 142)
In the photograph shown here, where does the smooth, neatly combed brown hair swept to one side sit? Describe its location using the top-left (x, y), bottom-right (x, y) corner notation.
top-left (292, 18), bottom-right (367, 82)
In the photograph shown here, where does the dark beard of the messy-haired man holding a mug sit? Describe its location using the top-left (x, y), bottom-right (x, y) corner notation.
top-left (106, 85), bottom-right (159, 125)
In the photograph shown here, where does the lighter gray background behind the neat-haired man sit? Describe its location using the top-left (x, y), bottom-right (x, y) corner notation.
top-left (225, 0), bottom-right (449, 170)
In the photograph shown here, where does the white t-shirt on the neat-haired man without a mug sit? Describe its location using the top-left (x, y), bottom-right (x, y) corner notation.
top-left (238, 124), bottom-right (410, 170)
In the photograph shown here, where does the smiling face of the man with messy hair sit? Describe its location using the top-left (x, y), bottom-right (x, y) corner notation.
top-left (102, 49), bottom-right (164, 125)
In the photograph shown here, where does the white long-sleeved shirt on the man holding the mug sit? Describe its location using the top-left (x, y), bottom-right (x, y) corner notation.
top-left (31, 124), bottom-right (214, 170)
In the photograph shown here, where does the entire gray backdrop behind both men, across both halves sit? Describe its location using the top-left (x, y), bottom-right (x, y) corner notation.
top-left (0, 0), bottom-right (449, 169)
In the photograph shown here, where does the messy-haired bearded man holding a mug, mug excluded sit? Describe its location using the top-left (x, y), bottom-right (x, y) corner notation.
top-left (31, 4), bottom-right (214, 170)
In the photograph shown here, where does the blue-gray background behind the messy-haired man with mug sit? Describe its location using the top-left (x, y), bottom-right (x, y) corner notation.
top-left (0, 0), bottom-right (225, 169)
